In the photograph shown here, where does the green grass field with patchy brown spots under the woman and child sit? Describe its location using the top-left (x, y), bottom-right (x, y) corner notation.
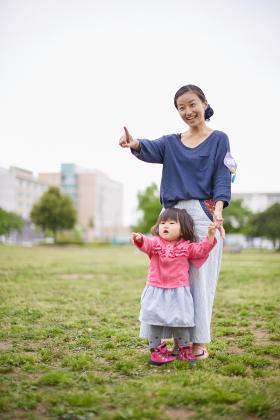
top-left (0, 246), bottom-right (280, 420)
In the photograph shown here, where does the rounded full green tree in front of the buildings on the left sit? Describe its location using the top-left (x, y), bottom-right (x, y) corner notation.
top-left (30, 187), bottom-right (77, 241)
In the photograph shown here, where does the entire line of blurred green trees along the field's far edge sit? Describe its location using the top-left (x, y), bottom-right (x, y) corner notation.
top-left (0, 183), bottom-right (280, 248)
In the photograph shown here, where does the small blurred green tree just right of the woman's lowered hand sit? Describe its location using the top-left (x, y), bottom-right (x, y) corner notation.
top-left (223, 200), bottom-right (252, 234)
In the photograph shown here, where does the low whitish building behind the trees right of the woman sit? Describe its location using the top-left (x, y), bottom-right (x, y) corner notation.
top-left (232, 192), bottom-right (280, 213)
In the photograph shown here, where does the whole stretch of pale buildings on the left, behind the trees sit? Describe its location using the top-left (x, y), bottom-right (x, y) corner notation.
top-left (0, 163), bottom-right (124, 240)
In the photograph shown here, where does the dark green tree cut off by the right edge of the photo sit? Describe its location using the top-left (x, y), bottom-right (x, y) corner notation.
top-left (249, 203), bottom-right (280, 248)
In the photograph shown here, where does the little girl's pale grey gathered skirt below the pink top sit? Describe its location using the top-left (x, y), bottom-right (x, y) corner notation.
top-left (139, 285), bottom-right (194, 327)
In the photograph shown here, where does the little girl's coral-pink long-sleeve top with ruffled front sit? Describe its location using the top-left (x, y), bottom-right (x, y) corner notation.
top-left (134, 235), bottom-right (217, 289)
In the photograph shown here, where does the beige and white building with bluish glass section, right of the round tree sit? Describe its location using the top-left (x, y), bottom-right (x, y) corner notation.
top-left (39, 163), bottom-right (123, 240)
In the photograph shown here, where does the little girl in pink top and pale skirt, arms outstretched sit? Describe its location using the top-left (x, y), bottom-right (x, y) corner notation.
top-left (131, 208), bottom-right (218, 365)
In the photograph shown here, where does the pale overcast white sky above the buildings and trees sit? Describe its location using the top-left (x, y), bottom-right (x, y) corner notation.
top-left (0, 0), bottom-right (280, 223)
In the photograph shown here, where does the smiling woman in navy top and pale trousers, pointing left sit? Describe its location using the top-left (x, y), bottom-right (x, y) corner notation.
top-left (119, 85), bottom-right (231, 359)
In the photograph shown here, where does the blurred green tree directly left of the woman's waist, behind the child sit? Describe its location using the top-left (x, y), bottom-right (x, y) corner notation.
top-left (132, 183), bottom-right (162, 233)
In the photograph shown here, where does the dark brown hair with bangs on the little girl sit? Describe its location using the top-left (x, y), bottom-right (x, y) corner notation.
top-left (151, 207), bottom-right (196, 242)
